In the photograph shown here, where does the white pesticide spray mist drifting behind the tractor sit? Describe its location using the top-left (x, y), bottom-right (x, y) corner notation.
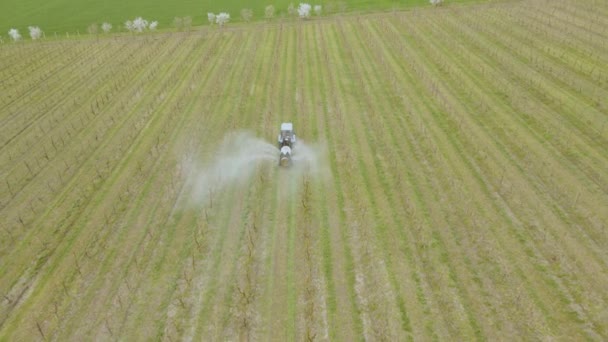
top-left (180, 131), bottom-right (330, 207)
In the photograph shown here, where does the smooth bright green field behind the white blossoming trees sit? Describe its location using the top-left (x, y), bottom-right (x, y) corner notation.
top-left (0, 0), bottom-right (478, 38)
